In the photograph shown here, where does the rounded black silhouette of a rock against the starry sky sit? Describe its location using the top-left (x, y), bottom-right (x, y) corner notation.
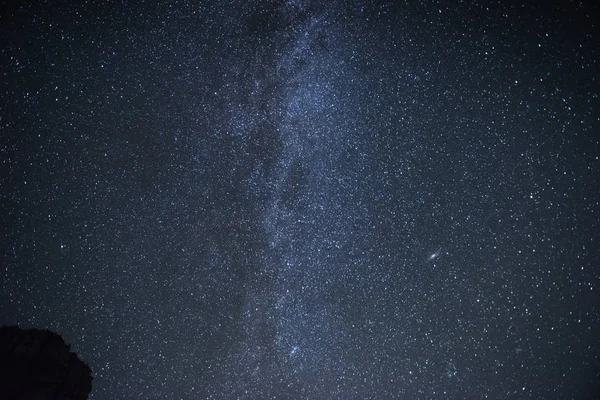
top-left (0, 326), bottom-right (92, 400)
